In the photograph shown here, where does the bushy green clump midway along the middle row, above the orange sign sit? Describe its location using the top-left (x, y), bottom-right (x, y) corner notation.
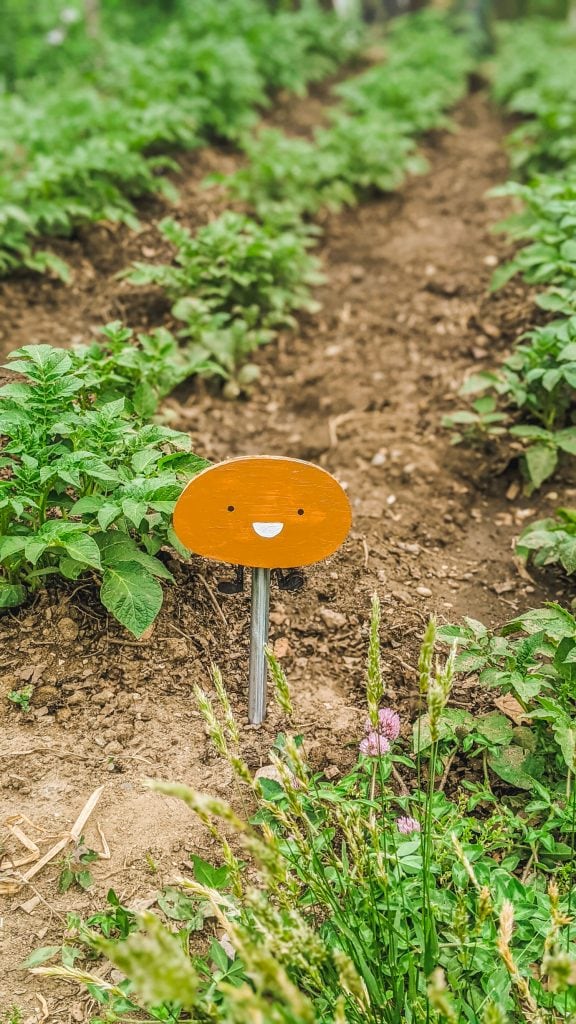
top-left (126, 212), bottom-right (322, 375)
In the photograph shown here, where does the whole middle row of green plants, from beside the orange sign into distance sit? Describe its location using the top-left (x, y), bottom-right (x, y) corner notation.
top-left (0, 14), bottom-right (469, 636)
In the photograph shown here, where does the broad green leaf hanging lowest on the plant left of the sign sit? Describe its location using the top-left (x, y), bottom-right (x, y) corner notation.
top-left (100, 561), bottom-right (163, 637)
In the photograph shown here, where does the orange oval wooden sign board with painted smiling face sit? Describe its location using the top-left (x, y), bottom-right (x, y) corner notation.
top-left (174, 456), bottom-right (352, 568)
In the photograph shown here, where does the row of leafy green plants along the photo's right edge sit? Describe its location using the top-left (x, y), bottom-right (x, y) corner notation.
top-left (446, 22), bottom-right (576, 573)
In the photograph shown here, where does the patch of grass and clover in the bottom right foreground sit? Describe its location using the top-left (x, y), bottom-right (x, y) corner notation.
top-left (35, 618), bottom-right (576, 1024)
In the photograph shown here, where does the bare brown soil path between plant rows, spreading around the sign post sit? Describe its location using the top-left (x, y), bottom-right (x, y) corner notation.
top-left (0, 93), bottom-right (558, 1022)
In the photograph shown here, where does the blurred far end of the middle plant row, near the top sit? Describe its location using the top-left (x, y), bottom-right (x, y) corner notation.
top-left (223, 12), bottom-right (470, 222)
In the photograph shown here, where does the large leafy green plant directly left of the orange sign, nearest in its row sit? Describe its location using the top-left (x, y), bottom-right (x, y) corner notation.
top-left (0, 339), bottom-right (205, 636)
